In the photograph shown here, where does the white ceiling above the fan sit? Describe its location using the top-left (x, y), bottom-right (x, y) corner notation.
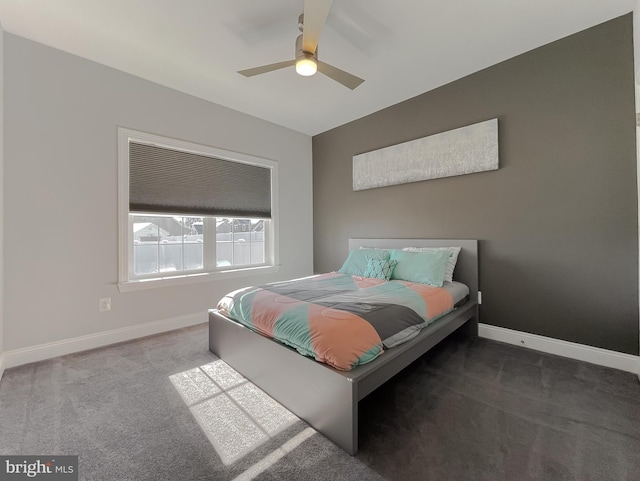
top-left (0, 0), bottom-right (635, 135)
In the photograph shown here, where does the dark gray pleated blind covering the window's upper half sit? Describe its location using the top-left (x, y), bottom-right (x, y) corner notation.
top-left (129, 141), bottom-right (271, 218)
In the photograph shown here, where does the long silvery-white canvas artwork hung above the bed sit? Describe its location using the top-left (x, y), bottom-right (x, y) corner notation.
top-left (353, 119), bottom-right (498, 190)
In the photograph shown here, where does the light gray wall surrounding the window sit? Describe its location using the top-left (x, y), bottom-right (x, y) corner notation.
top-left (4, 34), bottom-right (313, 352)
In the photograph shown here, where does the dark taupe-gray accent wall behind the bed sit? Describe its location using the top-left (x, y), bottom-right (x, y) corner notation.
top-left (313, 15), bottom-right (638, 355)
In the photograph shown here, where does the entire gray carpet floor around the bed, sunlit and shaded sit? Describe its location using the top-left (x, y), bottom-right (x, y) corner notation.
top-left (0, 325), bottom-right (640, 481)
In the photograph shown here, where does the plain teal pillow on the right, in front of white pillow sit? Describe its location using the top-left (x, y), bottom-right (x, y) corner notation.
top-left (391, 250), bottom-right (451, 287)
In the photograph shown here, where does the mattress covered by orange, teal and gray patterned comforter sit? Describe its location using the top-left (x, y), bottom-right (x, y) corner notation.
top-left (217, 272), bottom-right (469, 371)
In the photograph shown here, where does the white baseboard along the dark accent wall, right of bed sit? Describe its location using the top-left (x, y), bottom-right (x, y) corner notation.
top-left (478, 323), bottom-right (640, 377)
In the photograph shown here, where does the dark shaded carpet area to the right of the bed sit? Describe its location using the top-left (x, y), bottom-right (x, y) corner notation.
top-left (358, 330), bottom-right (640, 481)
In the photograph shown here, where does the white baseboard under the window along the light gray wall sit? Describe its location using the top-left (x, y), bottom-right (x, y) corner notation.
top-left (0, 311), bottom-right (207, 369)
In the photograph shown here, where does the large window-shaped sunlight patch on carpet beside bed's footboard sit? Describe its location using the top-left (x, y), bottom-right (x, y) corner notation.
top-left (169, 360), bottom-right (300, 465)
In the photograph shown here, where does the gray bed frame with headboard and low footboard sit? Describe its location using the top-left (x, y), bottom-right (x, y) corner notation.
top-left (209, 239), bottom-right (478, 455)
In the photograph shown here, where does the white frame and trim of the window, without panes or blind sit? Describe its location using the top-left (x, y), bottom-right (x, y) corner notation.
top-left (118, 127), bottom-right (279, 292)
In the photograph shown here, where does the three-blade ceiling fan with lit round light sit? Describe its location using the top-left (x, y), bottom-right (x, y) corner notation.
top-left (238, 0), bottom-right (364, 90)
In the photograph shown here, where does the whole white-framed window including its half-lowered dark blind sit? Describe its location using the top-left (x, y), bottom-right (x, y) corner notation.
top-left (118, 129), bottom-right (277, 290)
